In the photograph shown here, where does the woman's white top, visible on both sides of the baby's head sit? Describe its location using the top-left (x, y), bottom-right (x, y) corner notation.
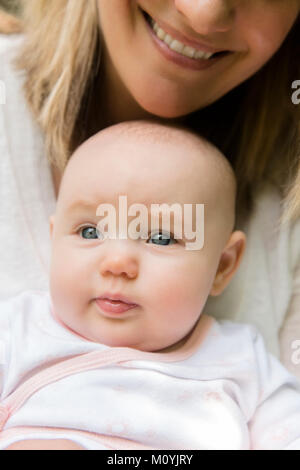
top-left (0, 35), bottom-right (300, 358)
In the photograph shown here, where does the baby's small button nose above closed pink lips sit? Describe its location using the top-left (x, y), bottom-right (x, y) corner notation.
top-left (100, 246), bottom-right (138, 279)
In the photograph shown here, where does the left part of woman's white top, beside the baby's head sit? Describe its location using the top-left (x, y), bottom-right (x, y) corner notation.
top-left (0, 36), bottom-right (55, 298)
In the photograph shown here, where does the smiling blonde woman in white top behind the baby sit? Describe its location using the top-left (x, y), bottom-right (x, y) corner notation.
top-left (0, 0), bottom-right (300, 377)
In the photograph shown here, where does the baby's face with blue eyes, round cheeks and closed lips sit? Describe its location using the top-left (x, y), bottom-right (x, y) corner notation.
top-left (51, 129), bottom-right (240, 351)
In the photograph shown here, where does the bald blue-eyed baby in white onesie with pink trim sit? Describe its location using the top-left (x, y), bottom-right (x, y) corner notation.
top-left (0, 121), bottom-right (300, 450)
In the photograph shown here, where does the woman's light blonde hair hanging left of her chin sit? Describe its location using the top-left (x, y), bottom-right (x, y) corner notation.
top-left (18, 0), bottom-right (99, 170)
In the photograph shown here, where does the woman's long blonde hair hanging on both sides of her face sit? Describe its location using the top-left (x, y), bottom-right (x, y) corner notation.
top-left (18, 0), bottom-right (300, 221)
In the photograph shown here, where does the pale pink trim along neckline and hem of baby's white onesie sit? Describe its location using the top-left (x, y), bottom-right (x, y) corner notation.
top-left (0, 314), bottom-right (214, 450)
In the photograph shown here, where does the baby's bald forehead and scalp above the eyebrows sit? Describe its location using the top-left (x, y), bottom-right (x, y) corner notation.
top-left (58, 121), bottom-right (236, 246)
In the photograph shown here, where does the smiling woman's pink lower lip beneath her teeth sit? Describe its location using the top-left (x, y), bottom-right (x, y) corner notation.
top-left (143, 11), bottom-right (222, 71)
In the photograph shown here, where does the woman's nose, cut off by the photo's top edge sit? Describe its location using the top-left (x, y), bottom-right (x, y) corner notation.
top-left (174, 0), bottom-right (236, 36)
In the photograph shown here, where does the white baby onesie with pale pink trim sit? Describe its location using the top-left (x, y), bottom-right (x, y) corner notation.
top-left (0, 291), bottom-right (300, 450)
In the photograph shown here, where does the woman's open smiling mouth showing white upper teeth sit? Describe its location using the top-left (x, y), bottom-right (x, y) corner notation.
top-left (141, 9), bottom-right (231, 61)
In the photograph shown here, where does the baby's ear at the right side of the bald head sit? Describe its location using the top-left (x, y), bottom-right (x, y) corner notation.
top-left (210, 231), bottom-right (246, 297)
